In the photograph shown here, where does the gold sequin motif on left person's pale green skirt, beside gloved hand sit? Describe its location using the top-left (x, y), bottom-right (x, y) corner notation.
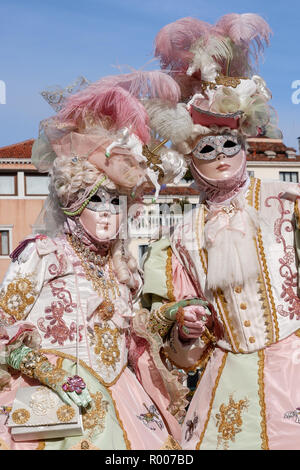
top-left (82, 392), bottom-right (108, 432)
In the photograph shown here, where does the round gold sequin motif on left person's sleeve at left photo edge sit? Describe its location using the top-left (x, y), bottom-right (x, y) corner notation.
top-left (0, 277), bottom-right (36, 320)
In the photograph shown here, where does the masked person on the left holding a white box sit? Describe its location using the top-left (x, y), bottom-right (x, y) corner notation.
top-left (0, 72), bottom-right (186, 450)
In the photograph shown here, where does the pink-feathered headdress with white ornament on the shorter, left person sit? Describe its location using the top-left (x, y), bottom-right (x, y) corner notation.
top-left (33, 71), bottom-right (186, 194)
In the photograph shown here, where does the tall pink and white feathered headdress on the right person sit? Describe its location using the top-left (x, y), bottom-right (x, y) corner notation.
top-left (151, 13), bottom-right (281, 147)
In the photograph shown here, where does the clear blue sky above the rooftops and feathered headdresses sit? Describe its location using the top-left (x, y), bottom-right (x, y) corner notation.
top-left (0, 0), bottom-right (300, 151)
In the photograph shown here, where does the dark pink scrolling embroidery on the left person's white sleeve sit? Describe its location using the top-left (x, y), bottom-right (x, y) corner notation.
top-left (37, 279), bottom-right (83, 346)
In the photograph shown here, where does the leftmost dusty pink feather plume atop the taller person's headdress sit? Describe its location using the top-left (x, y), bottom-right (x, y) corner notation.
top-left (155, 17), bottom-right (211, 73)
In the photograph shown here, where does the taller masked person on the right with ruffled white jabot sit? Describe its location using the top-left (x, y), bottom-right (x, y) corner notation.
top-left (134, 14), bottom-right (300, 450)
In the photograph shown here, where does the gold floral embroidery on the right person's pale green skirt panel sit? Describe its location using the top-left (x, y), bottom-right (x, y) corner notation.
top-left (216, 395), bottom-right (249, 449)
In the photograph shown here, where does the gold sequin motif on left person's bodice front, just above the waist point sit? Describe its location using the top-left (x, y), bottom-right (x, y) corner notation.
top-left (94, 325), bottom-right (120, 369)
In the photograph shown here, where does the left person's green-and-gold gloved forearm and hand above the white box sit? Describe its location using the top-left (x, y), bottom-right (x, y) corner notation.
top-left (7, 345), bottom-right (92, 407)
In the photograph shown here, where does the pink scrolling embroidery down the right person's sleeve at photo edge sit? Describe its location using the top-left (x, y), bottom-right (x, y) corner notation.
top-left (265, 193), bottom-right (300, 320)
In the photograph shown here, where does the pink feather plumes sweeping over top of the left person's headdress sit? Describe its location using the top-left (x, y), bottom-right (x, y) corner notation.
top-left (59, 70), bottom-right (180, 143)
